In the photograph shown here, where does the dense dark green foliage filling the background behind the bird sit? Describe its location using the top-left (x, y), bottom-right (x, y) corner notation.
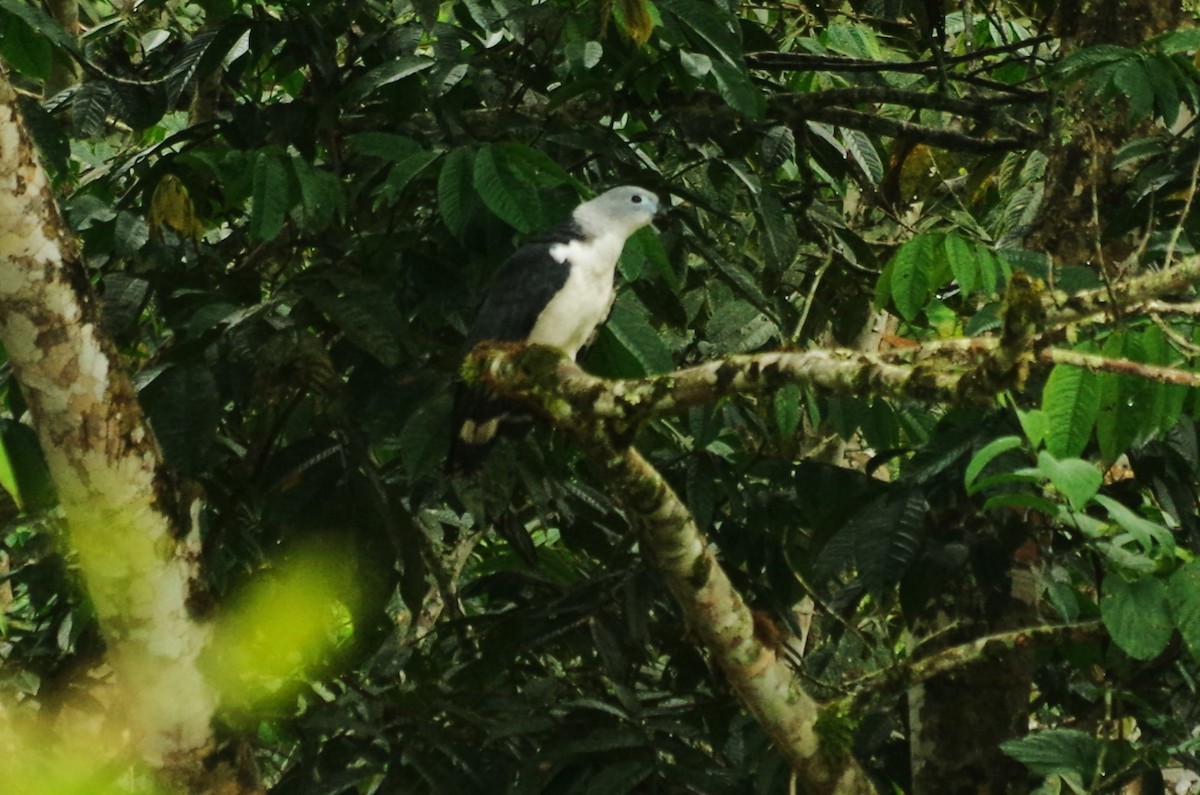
top-left (0, 0), bottom-right (1200, 794)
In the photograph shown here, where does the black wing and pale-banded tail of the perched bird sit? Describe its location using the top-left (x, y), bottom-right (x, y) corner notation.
top-left (446, 225), bottom-right (576, 472)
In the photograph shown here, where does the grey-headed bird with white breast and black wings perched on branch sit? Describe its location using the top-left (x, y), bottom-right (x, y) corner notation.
top-left (446, 185), bottom-right (660, 472)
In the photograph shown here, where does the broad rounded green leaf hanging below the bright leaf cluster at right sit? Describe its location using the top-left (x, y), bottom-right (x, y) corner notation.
top-left (1100, 574), bottom-right (1175, 659)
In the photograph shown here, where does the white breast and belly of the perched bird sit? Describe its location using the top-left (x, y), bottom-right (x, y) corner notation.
top-left (529, 235), bottom-right (625, 359)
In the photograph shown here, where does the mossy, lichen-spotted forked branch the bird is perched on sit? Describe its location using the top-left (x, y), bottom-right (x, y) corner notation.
top-left (463, 258), bottom-right (1200, 793)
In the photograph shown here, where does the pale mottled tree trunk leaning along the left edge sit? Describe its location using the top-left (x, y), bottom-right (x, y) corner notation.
top-left (0, 66), bottom-right (216, 766)
